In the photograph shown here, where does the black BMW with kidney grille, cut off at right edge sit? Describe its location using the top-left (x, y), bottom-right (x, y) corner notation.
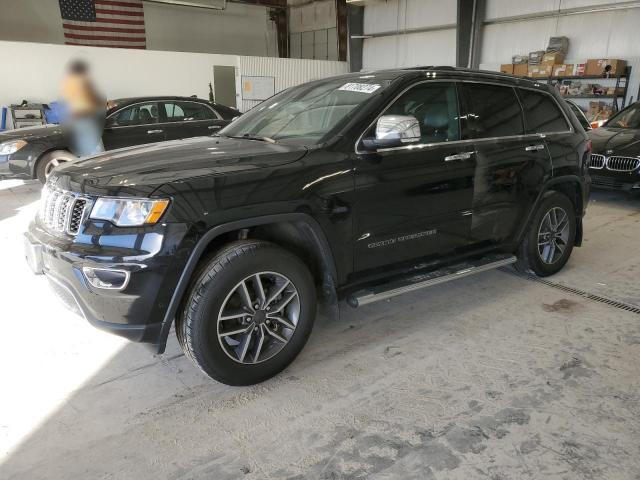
top-left (588, 102), bottom-right (640, 192)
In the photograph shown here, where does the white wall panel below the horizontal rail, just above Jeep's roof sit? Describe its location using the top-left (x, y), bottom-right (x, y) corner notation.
top-left (362, 29), bottom-right (456, 70)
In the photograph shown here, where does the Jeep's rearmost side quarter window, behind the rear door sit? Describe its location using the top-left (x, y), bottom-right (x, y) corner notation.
top-left (520, 88), bottom-right (570, 133)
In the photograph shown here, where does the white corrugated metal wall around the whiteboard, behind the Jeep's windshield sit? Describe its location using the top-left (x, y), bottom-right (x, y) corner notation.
top-left (236, 57), bottom-right (349, 112)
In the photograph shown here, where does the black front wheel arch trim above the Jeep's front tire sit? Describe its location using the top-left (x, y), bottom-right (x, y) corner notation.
top-left (152, 213), bottom-right (337, 353)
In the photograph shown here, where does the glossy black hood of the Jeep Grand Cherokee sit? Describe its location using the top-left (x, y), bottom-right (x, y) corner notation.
top-left (55, 137), bottom-right (307, 195)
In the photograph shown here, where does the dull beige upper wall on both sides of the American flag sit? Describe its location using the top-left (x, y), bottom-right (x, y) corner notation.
top-left (0, 0), bottom-right (278, 56)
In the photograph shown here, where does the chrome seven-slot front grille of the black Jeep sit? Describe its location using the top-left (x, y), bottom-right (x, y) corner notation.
top-left (40, 185), bottom-right (88, 235)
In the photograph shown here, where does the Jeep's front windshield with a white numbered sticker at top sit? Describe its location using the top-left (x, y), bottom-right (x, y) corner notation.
top-left (220, 75), bottom-right (389, 145)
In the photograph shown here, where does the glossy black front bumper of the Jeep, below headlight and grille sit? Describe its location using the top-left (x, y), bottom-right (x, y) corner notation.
top-left (25, 220), bottom-right (192, 351)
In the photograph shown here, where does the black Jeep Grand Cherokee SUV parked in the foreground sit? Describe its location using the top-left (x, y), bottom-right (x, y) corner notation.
top-left (25, 67), bottom-right (589, 385)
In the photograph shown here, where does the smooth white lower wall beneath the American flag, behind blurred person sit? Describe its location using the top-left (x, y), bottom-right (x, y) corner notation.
top-left (0, 41), bottom-right (237, 109)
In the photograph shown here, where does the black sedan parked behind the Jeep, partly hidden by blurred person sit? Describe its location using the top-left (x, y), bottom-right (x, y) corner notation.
top-left (0, 97), bottom-right (240, 183)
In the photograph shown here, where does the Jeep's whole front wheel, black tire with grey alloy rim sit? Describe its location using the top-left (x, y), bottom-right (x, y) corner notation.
top-left (176, 240), bottom-right (317, 385)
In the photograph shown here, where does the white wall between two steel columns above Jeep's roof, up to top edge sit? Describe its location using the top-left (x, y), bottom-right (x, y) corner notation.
top-left (363, 0), bottom-right (457, 70)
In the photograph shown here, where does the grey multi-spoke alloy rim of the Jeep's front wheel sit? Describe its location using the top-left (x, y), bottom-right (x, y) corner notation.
top-left (216, 272), bottom-right (300, 364)
